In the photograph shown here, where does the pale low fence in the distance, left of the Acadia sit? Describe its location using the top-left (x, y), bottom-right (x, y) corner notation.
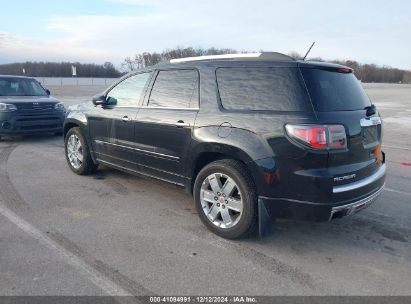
top-left (35, 77), bottom-right (118, 86)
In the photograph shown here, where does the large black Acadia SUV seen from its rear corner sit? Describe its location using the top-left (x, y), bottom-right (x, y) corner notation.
top-left (64, 53), bottom-right (386, 238)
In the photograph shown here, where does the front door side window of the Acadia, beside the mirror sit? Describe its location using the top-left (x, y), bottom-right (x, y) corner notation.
top-left (107, 73), bottom-right (151, 107)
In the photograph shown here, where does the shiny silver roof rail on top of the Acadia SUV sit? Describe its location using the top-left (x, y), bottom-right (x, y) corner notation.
top-left (170, 52), bottom-right (295, 63)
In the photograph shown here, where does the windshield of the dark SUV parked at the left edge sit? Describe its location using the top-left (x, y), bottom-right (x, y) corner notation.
top-left (0, 77), bottom-right (47, 96)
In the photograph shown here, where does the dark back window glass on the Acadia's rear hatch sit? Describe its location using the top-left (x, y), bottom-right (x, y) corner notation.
top-left (301, 68), bottom-right (371, 112)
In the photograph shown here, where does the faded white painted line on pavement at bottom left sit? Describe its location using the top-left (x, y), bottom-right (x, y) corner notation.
top-left (0, 202), bottom-right (132, 296)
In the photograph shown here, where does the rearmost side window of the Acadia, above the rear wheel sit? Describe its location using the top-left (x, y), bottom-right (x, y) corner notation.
top-left (217, 67), bottom-right (310, 111)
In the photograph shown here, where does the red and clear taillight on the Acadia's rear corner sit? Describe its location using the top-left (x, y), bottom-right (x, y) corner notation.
top-left (285, 125), bottom-right (347, 150)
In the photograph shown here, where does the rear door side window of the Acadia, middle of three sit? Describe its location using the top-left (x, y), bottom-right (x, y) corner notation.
top-left (149, 70), bottom-right (198, 108)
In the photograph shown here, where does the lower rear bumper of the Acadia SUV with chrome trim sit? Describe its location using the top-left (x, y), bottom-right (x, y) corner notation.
top-left (259, 165), bottom-right (385, 222)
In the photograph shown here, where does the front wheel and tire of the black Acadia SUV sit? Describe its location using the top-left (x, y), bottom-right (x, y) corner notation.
top-left (64, 127), bottom-right (97, 175)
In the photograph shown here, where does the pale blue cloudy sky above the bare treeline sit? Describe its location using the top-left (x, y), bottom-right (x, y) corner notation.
top-left (0, 0), bottom-right (411, 70)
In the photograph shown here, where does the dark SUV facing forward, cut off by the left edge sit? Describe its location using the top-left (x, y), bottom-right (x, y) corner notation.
top-left (0, 75), bottom-right (65, 139)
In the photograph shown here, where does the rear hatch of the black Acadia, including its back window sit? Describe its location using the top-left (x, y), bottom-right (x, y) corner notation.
top-left (301, 65), bottom-right (384, 199)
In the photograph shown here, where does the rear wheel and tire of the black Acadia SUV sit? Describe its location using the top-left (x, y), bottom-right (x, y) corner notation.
top-left (193, 159), bottom-right (257, 239)
